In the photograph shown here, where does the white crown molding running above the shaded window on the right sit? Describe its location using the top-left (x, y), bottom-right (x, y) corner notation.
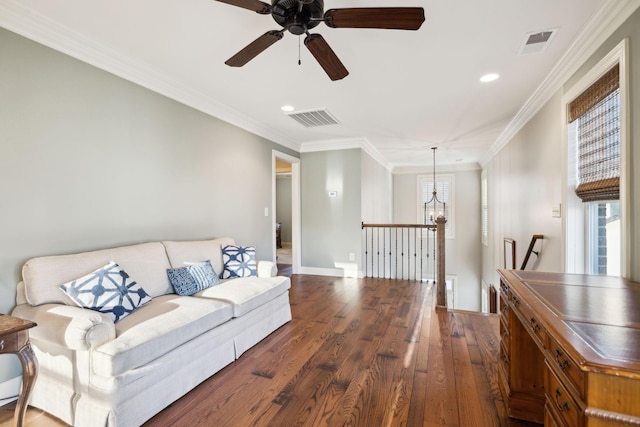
top-left (480, 0), bottom-right (640, 167)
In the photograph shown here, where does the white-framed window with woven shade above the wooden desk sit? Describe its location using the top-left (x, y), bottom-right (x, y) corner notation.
top-left (564, 42), bottom-right (627, 275)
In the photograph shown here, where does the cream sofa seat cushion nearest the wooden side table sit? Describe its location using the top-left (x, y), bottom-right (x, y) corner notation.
top-left (92, 294), bottom-right (233, 376)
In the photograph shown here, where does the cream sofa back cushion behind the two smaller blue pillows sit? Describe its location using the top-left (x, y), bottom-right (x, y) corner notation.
top-left (162, 237), bottom-right (235, 275)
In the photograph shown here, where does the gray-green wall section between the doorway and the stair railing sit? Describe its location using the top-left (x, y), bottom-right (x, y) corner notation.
top-left (300, 148), bottom-right (362, 269)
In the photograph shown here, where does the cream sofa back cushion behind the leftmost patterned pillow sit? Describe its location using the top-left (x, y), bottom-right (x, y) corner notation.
top-left (22, 242), bottom-right (173, 305)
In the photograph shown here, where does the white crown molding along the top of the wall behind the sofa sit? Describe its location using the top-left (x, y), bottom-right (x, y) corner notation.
top-left (0, 0), bottom-right (300, 151)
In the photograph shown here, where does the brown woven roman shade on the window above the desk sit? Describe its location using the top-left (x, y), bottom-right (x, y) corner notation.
top-left (569, 66), bottom-right (620, 202)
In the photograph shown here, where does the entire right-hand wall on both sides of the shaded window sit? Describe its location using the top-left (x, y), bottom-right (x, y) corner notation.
top-left (482, 5), bottom-right (640, 284)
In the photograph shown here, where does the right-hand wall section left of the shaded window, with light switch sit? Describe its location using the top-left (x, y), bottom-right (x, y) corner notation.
top-left (483, 95), bottom-right (563, 286)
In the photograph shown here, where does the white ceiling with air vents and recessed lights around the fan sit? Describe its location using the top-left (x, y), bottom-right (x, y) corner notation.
top-left (0, 0), bottom-right (640, 171)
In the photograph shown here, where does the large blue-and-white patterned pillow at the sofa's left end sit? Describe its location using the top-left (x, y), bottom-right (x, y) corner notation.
top-left (60, 261), bottom-right (151, 323)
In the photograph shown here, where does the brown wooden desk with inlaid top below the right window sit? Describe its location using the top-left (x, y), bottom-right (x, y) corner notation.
top-left (498, 270), bottom-right (640, 427)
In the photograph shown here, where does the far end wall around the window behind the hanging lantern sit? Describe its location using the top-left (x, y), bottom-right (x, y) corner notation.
top-left (393, 167), bottom-right (482, 311)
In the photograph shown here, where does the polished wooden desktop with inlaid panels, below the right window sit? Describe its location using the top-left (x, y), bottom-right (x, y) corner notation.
top-left (499, 270), bottom-right (640, 377)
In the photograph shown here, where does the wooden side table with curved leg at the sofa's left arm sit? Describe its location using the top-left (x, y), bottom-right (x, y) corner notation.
top-left (0, 314), bottom-right (38, 427)
